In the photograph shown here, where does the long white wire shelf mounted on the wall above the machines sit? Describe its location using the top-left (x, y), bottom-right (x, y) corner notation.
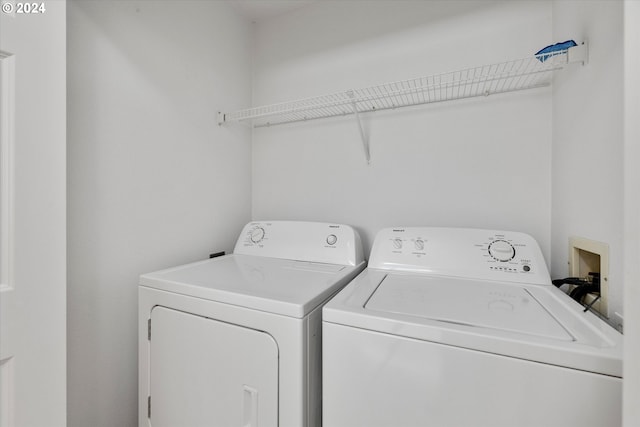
top-left (218, 44), bottom-right (587, 127)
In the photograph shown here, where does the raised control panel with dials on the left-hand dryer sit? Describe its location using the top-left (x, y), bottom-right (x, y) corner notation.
top-left (233, 221), bottom-right (364, 265)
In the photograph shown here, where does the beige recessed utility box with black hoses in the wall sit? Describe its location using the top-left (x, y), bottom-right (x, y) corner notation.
top-left (569, 237), bottom-right (609, 318)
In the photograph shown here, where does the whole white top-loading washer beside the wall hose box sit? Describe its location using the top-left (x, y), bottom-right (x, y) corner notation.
top-left (323, 227), bottom-right (622, 427)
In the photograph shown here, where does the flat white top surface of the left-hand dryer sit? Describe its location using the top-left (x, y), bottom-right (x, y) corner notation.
top-left (140, 254), bottom-right (364, 318)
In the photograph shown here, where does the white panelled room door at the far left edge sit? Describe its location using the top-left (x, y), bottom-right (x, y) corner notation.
top-left (0, 1), bottom-right (66, 427)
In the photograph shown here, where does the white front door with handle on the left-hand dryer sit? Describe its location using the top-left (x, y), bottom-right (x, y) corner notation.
top-left (148, 307), bottom-right (278, 427)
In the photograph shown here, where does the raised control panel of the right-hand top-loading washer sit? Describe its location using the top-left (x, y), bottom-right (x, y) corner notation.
top-left (369, 227), bottom-right (551, 285)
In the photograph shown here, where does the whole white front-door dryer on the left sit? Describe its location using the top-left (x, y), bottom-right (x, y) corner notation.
top-left (138, 221), bottom-right (365, 427)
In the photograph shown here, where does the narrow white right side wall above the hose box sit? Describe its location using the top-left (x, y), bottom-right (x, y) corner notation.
top-left (551, 0), bottom-right (624, 324)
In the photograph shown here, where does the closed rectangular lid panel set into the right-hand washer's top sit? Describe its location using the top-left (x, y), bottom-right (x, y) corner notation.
top-left (365, 275), bottom-right (573, 341)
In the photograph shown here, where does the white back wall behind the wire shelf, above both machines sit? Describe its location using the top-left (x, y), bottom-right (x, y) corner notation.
top-left (252, 1), bottom-right (551, 257)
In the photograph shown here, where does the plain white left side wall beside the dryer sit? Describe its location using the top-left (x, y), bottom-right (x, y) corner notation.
top-left (68, 1), bottom-right (251, 427)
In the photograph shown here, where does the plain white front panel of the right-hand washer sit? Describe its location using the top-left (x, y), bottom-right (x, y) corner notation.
top-left (322, 322), bottom-right (622, 427)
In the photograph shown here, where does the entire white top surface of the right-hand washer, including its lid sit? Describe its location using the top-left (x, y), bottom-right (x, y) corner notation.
top-left (322, 268), bottom-right (622, 377)
